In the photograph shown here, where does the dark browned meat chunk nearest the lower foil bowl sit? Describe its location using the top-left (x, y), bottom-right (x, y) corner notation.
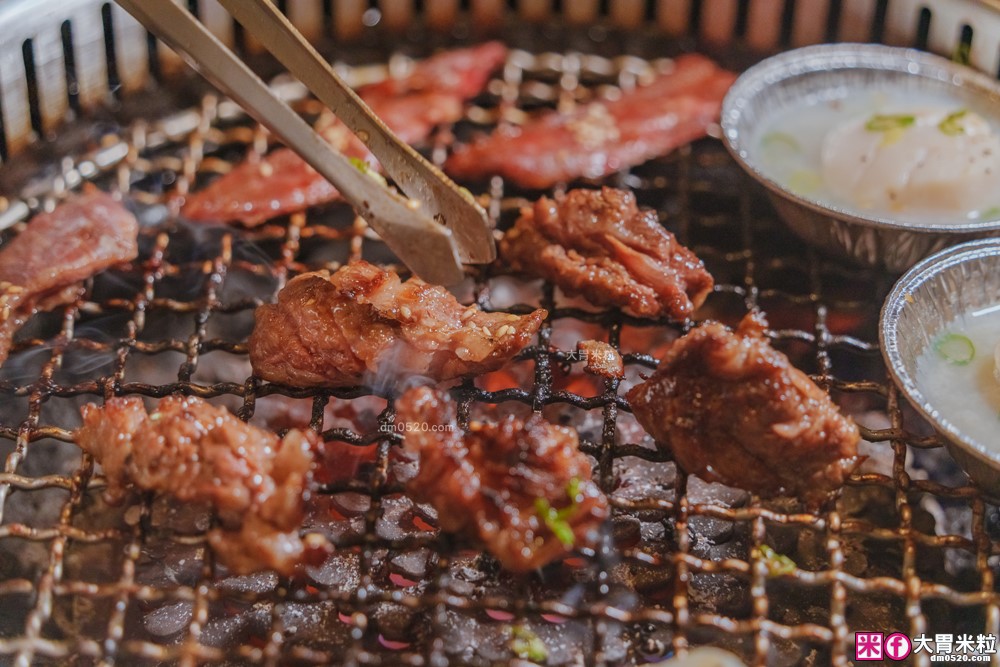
top-left (627, 313), bottom-right (860, 505)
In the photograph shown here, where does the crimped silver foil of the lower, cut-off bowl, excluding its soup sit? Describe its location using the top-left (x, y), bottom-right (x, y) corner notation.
top-left (879, 239), bottom-right (1000, 499)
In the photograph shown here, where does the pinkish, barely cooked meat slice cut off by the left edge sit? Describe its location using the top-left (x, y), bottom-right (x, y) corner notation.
top-left (0, 188), bottom-right (139, 364)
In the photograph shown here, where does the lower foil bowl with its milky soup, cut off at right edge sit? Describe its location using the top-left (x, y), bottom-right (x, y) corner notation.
top-left (879, 239), bottom-right (1000, 498)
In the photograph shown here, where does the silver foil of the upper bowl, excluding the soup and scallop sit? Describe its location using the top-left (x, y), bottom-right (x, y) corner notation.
top-left (722, 44), bottom-right (1000, 272)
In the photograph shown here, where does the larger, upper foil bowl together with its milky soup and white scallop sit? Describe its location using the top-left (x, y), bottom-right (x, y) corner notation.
top-left (722, 44), bottom-right (1000, 272)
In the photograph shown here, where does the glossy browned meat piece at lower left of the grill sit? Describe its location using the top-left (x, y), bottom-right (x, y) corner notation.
top-left (74, 396), bottom-right (328, 575)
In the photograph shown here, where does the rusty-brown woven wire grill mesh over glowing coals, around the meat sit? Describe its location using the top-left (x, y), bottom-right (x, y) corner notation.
top-left (0, 24), bottom-right (1000, 665)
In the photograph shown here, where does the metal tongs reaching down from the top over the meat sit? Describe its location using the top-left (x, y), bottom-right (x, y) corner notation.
top-left (117, 0), bottom-right (496, 285)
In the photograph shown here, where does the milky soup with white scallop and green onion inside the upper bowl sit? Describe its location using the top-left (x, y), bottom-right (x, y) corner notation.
top-left (753, 85), bottom-right (1000, 226)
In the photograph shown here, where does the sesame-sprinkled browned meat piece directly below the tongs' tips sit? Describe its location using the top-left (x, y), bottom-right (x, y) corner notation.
top-left (249, 261), bottom-right (546, 387)
